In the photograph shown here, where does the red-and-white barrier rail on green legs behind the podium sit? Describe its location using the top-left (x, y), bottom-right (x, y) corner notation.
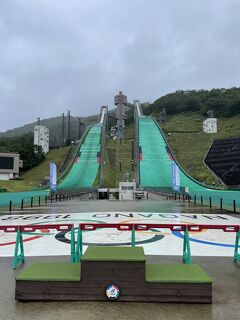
top-left (0, 223), bottom-right (240, 270)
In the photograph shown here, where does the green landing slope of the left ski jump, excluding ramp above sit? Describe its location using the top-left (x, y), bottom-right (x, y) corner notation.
top-left (58, 124), bottom-right (102, 189)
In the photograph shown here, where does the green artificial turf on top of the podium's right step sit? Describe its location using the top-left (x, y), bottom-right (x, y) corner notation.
top-left (146, 264), bottom-right (213, 283)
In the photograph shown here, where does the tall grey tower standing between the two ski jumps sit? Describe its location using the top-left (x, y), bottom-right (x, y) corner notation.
top-left (114, 91), bottom-right (127, 139)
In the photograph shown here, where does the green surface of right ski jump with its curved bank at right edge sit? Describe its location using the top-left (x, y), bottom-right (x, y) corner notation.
top-left (139, 117), bottom-right (240, 208)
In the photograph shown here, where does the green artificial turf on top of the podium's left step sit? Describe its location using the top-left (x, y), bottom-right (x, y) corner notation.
top-left (16, 263), bottom-right (81, 281)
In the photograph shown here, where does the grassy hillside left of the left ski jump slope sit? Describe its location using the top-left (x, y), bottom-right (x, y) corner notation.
top-left (0, 147), bottom-right (69, 191)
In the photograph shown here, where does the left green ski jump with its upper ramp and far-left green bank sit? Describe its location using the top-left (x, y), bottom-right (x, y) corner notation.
top-left (0, 107), bottom-right (107, 207)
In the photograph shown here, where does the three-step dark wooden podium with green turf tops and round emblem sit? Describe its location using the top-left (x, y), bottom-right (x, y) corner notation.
top-left (15, 246), bottom-right (212, 303)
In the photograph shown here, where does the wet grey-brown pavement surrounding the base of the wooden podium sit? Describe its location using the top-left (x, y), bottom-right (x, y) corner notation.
top-left (0, 256), bottom-right (240, 320)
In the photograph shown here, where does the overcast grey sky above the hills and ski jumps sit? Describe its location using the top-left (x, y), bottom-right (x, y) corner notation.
top-left (0, 0), bottom-right (240, 131)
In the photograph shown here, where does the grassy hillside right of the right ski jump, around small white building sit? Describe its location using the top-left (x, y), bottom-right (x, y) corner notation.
top-left (156, 112), bottom-right (240, 185)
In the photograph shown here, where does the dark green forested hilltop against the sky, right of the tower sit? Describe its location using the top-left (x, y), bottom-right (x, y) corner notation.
top-left (144, 88), bottom-right (240, 117)
